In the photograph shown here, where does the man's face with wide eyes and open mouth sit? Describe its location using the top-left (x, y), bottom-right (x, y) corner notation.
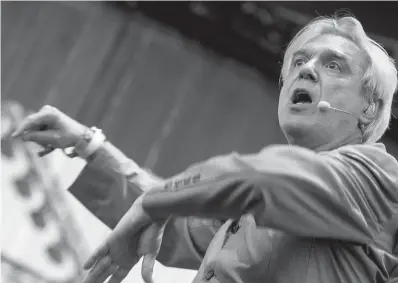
top-left (278, 34), bottom-right (367, 142)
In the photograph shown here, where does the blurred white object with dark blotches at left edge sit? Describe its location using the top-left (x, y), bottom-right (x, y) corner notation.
top-left (1, 102), bottom-right (88, 283)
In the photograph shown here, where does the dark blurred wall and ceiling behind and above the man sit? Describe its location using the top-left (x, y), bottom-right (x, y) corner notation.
top-left (1, 2), bottom-right (398, 176)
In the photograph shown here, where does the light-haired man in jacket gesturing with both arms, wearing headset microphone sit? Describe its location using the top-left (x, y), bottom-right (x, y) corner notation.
top-left (15, 14), bottom-right (398, 283)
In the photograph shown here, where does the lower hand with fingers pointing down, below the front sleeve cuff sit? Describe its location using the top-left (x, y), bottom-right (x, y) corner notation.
top-left (83, 195), bottom-right (165, 283)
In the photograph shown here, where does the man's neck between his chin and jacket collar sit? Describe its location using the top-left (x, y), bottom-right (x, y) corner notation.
top-left (287, 133), bottom-right (362, 152)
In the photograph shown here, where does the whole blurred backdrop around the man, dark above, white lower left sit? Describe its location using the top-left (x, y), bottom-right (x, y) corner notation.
top-left (1, 1), bottom-right (398, 283)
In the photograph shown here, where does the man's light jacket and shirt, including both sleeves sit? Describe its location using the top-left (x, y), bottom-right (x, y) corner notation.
top-left (70, 144), bottom-right (398, 283)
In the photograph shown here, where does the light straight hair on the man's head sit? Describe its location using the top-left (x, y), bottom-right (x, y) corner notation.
top-left (281, 16), bottom-right (398, 143)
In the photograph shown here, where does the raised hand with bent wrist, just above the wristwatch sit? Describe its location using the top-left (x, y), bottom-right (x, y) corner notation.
top-left (12, 105), bottom-right (87, 148)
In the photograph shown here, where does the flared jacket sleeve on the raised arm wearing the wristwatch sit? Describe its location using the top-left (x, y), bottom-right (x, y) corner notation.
top-left (69, 142), bottom-right (145, 229)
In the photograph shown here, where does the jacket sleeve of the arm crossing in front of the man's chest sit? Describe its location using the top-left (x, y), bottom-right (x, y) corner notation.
top-left (143, 146), bottom-right (398, 248)
